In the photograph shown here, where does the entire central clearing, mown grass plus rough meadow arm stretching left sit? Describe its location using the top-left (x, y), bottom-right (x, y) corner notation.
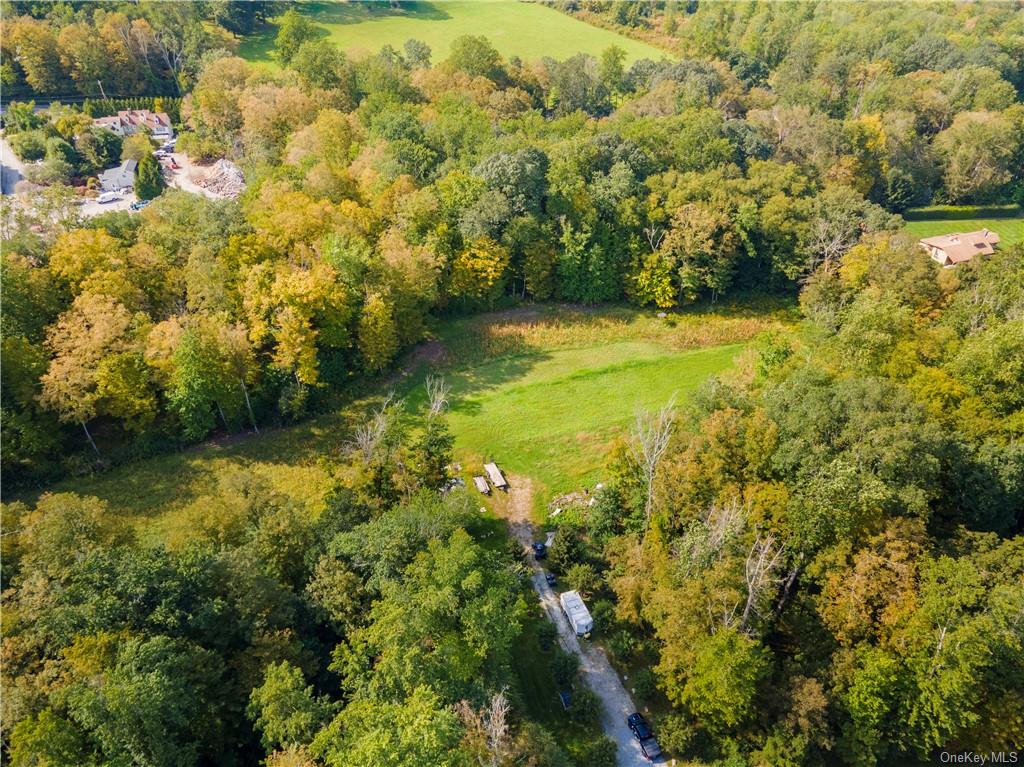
top-left (25, 304), bottom-right (793, 543)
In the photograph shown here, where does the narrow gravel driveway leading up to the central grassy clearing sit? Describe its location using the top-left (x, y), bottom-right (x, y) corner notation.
top-left (509, 476), bottom-right (665, 767)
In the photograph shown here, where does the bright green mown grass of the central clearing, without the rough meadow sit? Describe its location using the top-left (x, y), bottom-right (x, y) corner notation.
top-left (449, 342), bottom-right (742, 497)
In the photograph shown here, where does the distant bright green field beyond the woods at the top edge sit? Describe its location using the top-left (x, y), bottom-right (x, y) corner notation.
top-left (239, 0), bottom-right (669, 67)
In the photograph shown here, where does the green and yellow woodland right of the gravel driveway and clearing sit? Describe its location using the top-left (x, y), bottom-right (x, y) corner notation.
top-left (585, 236), bottom-right (1024, 765)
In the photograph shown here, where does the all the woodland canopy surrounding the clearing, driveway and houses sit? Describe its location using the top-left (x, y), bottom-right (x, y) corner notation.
top-left (0, 0), bottom-right (1024, 767)
